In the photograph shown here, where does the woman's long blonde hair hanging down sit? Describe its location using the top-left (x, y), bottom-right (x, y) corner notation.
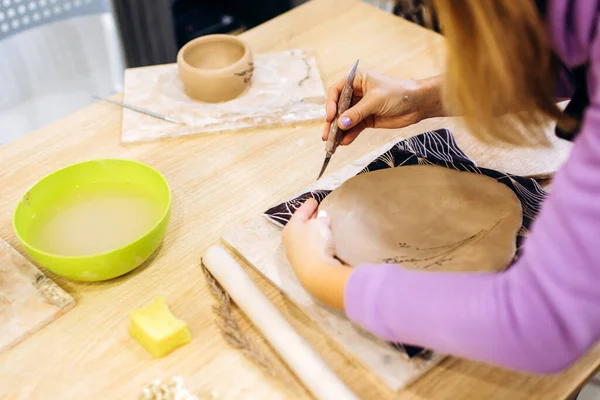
top-left (432, 0), bottom-right (573, 144)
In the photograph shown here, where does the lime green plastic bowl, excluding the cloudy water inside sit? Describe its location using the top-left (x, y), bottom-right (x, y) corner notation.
top-left (13, 159), bottom-right (171, 281)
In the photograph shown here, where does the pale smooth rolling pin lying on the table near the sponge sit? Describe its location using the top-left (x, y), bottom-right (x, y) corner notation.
top-left (202, 246), bottom-right (358, 400)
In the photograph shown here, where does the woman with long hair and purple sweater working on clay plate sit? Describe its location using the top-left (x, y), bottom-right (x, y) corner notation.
top-left (283, 0), bottom-right (600, 373)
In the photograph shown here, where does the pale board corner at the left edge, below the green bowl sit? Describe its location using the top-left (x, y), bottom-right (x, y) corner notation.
top-left (0, 239), bottom-right (75, 353)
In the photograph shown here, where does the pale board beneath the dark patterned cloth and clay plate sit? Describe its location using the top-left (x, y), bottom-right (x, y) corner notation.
top-left (222, 141), bottom-right (442, 391)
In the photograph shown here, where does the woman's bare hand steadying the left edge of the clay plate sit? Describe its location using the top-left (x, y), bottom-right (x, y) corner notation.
top-left (282, 199), bottom-right (351, 309)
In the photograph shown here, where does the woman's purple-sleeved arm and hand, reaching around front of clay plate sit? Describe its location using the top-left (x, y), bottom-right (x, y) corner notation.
top-left (284, 76), bottom-right (600, 372)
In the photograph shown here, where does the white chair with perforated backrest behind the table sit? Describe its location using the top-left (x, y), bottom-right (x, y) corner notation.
top-left (0, 0), bottom-right (125, 145)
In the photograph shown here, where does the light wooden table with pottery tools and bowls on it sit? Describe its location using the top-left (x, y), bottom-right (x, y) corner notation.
top-left (0, 0), bottom-right (600, 400)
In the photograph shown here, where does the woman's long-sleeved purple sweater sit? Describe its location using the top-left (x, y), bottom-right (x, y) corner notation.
top-left (345, 0), bottom-right (600, 373)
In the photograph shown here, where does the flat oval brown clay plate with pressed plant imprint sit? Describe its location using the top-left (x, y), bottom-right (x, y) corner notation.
top-left (320, 165), bottom-right (522, 272)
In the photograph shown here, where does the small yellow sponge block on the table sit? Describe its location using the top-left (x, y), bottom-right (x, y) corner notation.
top-left (129, 296), bottom-right (192, 357)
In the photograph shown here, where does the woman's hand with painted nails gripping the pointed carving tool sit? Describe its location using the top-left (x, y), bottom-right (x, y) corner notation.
top-left (323, 71), bottom-right (443, 146)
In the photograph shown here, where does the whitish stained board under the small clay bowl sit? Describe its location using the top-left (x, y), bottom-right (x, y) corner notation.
top-left (121, 50), bottom-right (325, 143)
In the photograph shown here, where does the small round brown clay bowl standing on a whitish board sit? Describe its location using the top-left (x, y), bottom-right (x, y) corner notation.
top-left (177, 35), bottom-right (254, 103)
